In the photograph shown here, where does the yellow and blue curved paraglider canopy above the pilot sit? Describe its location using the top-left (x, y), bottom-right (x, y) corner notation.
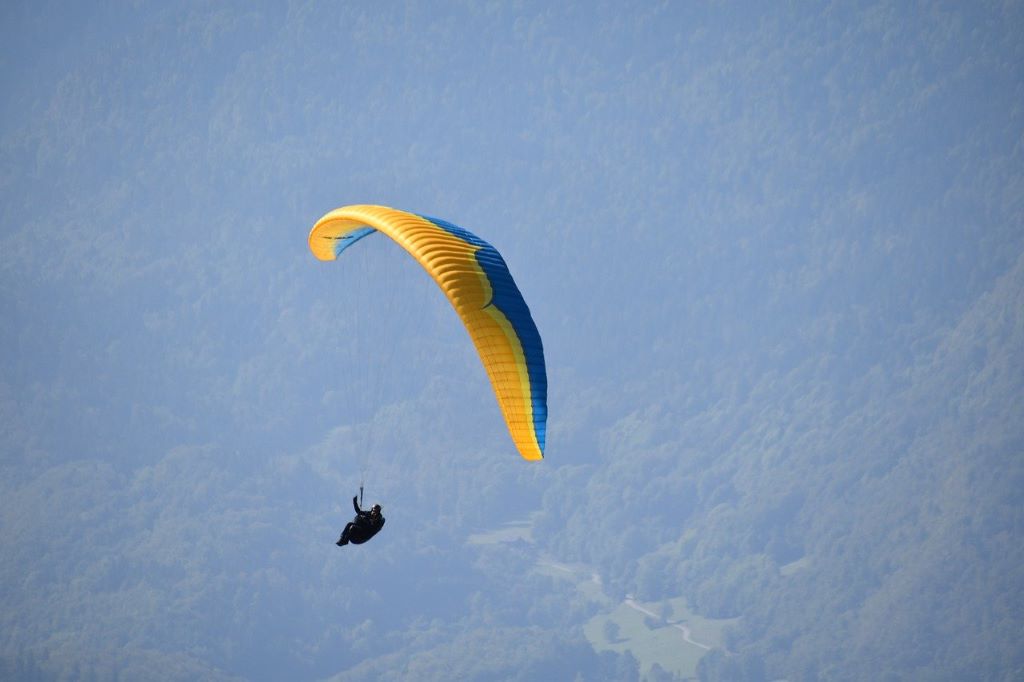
top-left (309, 200), bottom-right (548, 456)
